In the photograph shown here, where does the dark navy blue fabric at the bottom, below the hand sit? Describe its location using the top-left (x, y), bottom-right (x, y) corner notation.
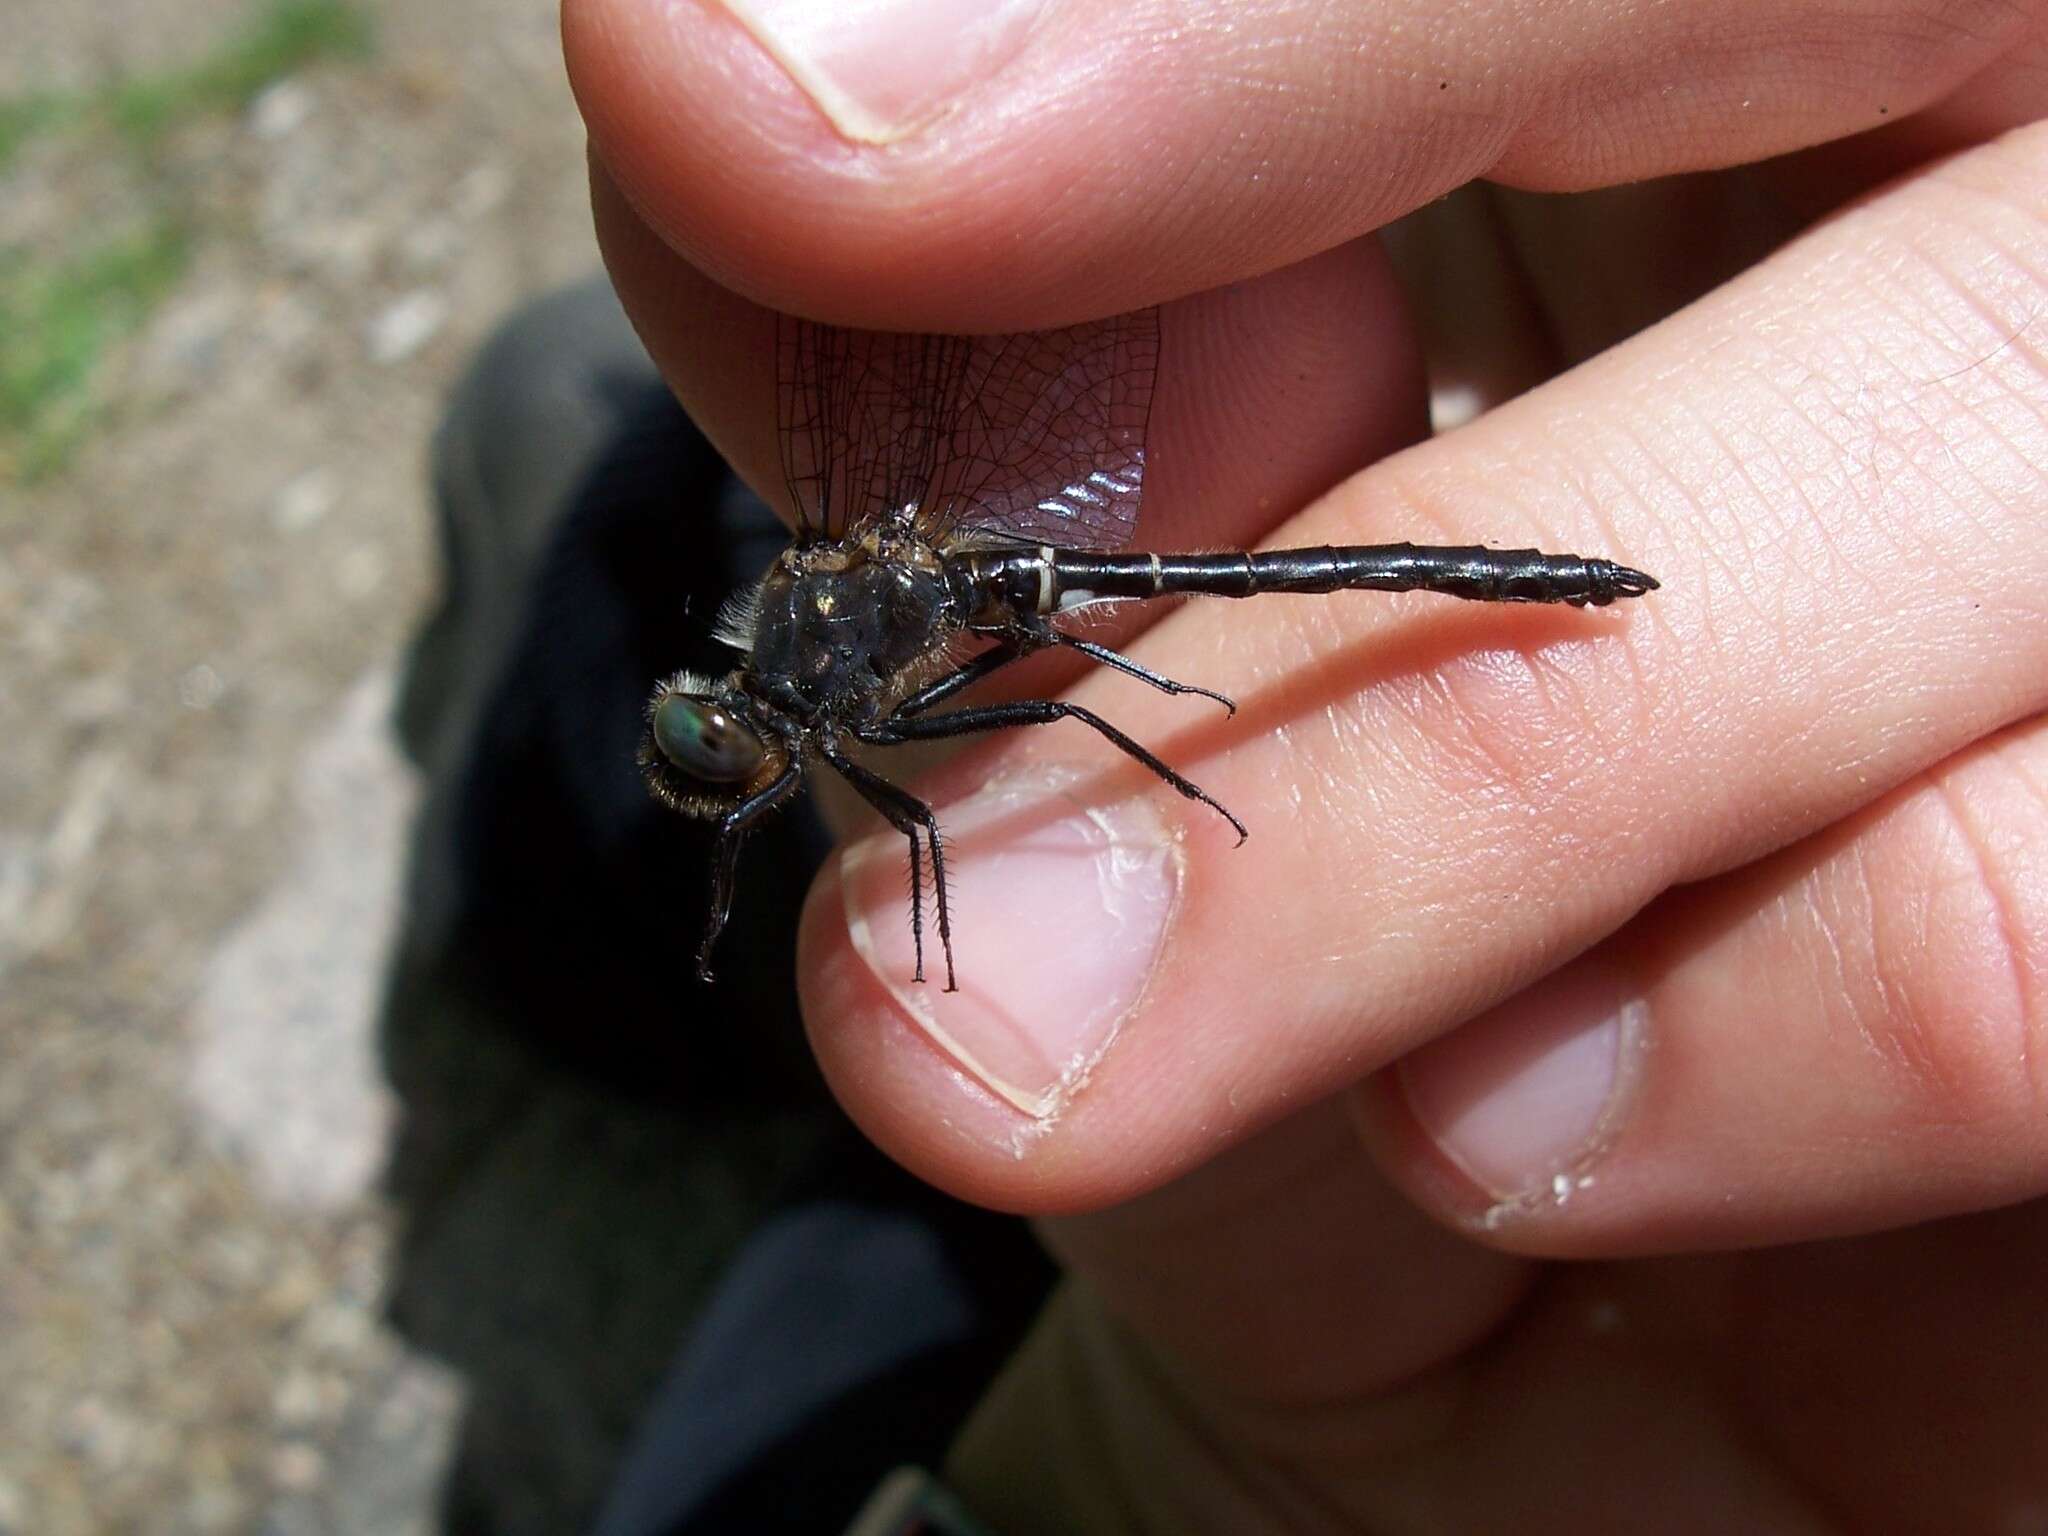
top-left (598, 1192), bottom-right (1049, 1536)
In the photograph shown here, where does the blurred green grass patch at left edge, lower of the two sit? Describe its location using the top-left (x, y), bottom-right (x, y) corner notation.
top-left (0, 219), bottom-right (190, 481)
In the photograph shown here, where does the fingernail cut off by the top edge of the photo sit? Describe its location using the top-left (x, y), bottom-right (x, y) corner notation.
top-left (723, 0), bottom-right (1044, 143)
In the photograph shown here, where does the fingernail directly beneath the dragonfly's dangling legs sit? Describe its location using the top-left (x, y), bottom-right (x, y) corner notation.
top-left (840, 768), bottom-right (1182, 1118)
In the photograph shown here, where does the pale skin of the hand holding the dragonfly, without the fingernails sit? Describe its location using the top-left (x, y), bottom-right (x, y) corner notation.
top-left (565, 0), bottom-right (2048, 1536)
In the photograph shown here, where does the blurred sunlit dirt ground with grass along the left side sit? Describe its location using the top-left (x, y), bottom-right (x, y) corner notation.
top-left (0, 0), bottom-right (596, 1536)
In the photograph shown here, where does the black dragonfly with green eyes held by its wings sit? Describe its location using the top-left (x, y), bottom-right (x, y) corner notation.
top-left (639, 309), bottom-right (1657, 991)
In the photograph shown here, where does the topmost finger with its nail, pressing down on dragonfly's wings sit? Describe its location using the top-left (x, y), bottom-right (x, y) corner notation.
top-left (563, 0), bottom-right (2042, 332)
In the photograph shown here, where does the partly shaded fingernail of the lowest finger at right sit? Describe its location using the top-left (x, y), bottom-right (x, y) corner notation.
top-left (1397, 963), bottom-right (1647, 1200)
